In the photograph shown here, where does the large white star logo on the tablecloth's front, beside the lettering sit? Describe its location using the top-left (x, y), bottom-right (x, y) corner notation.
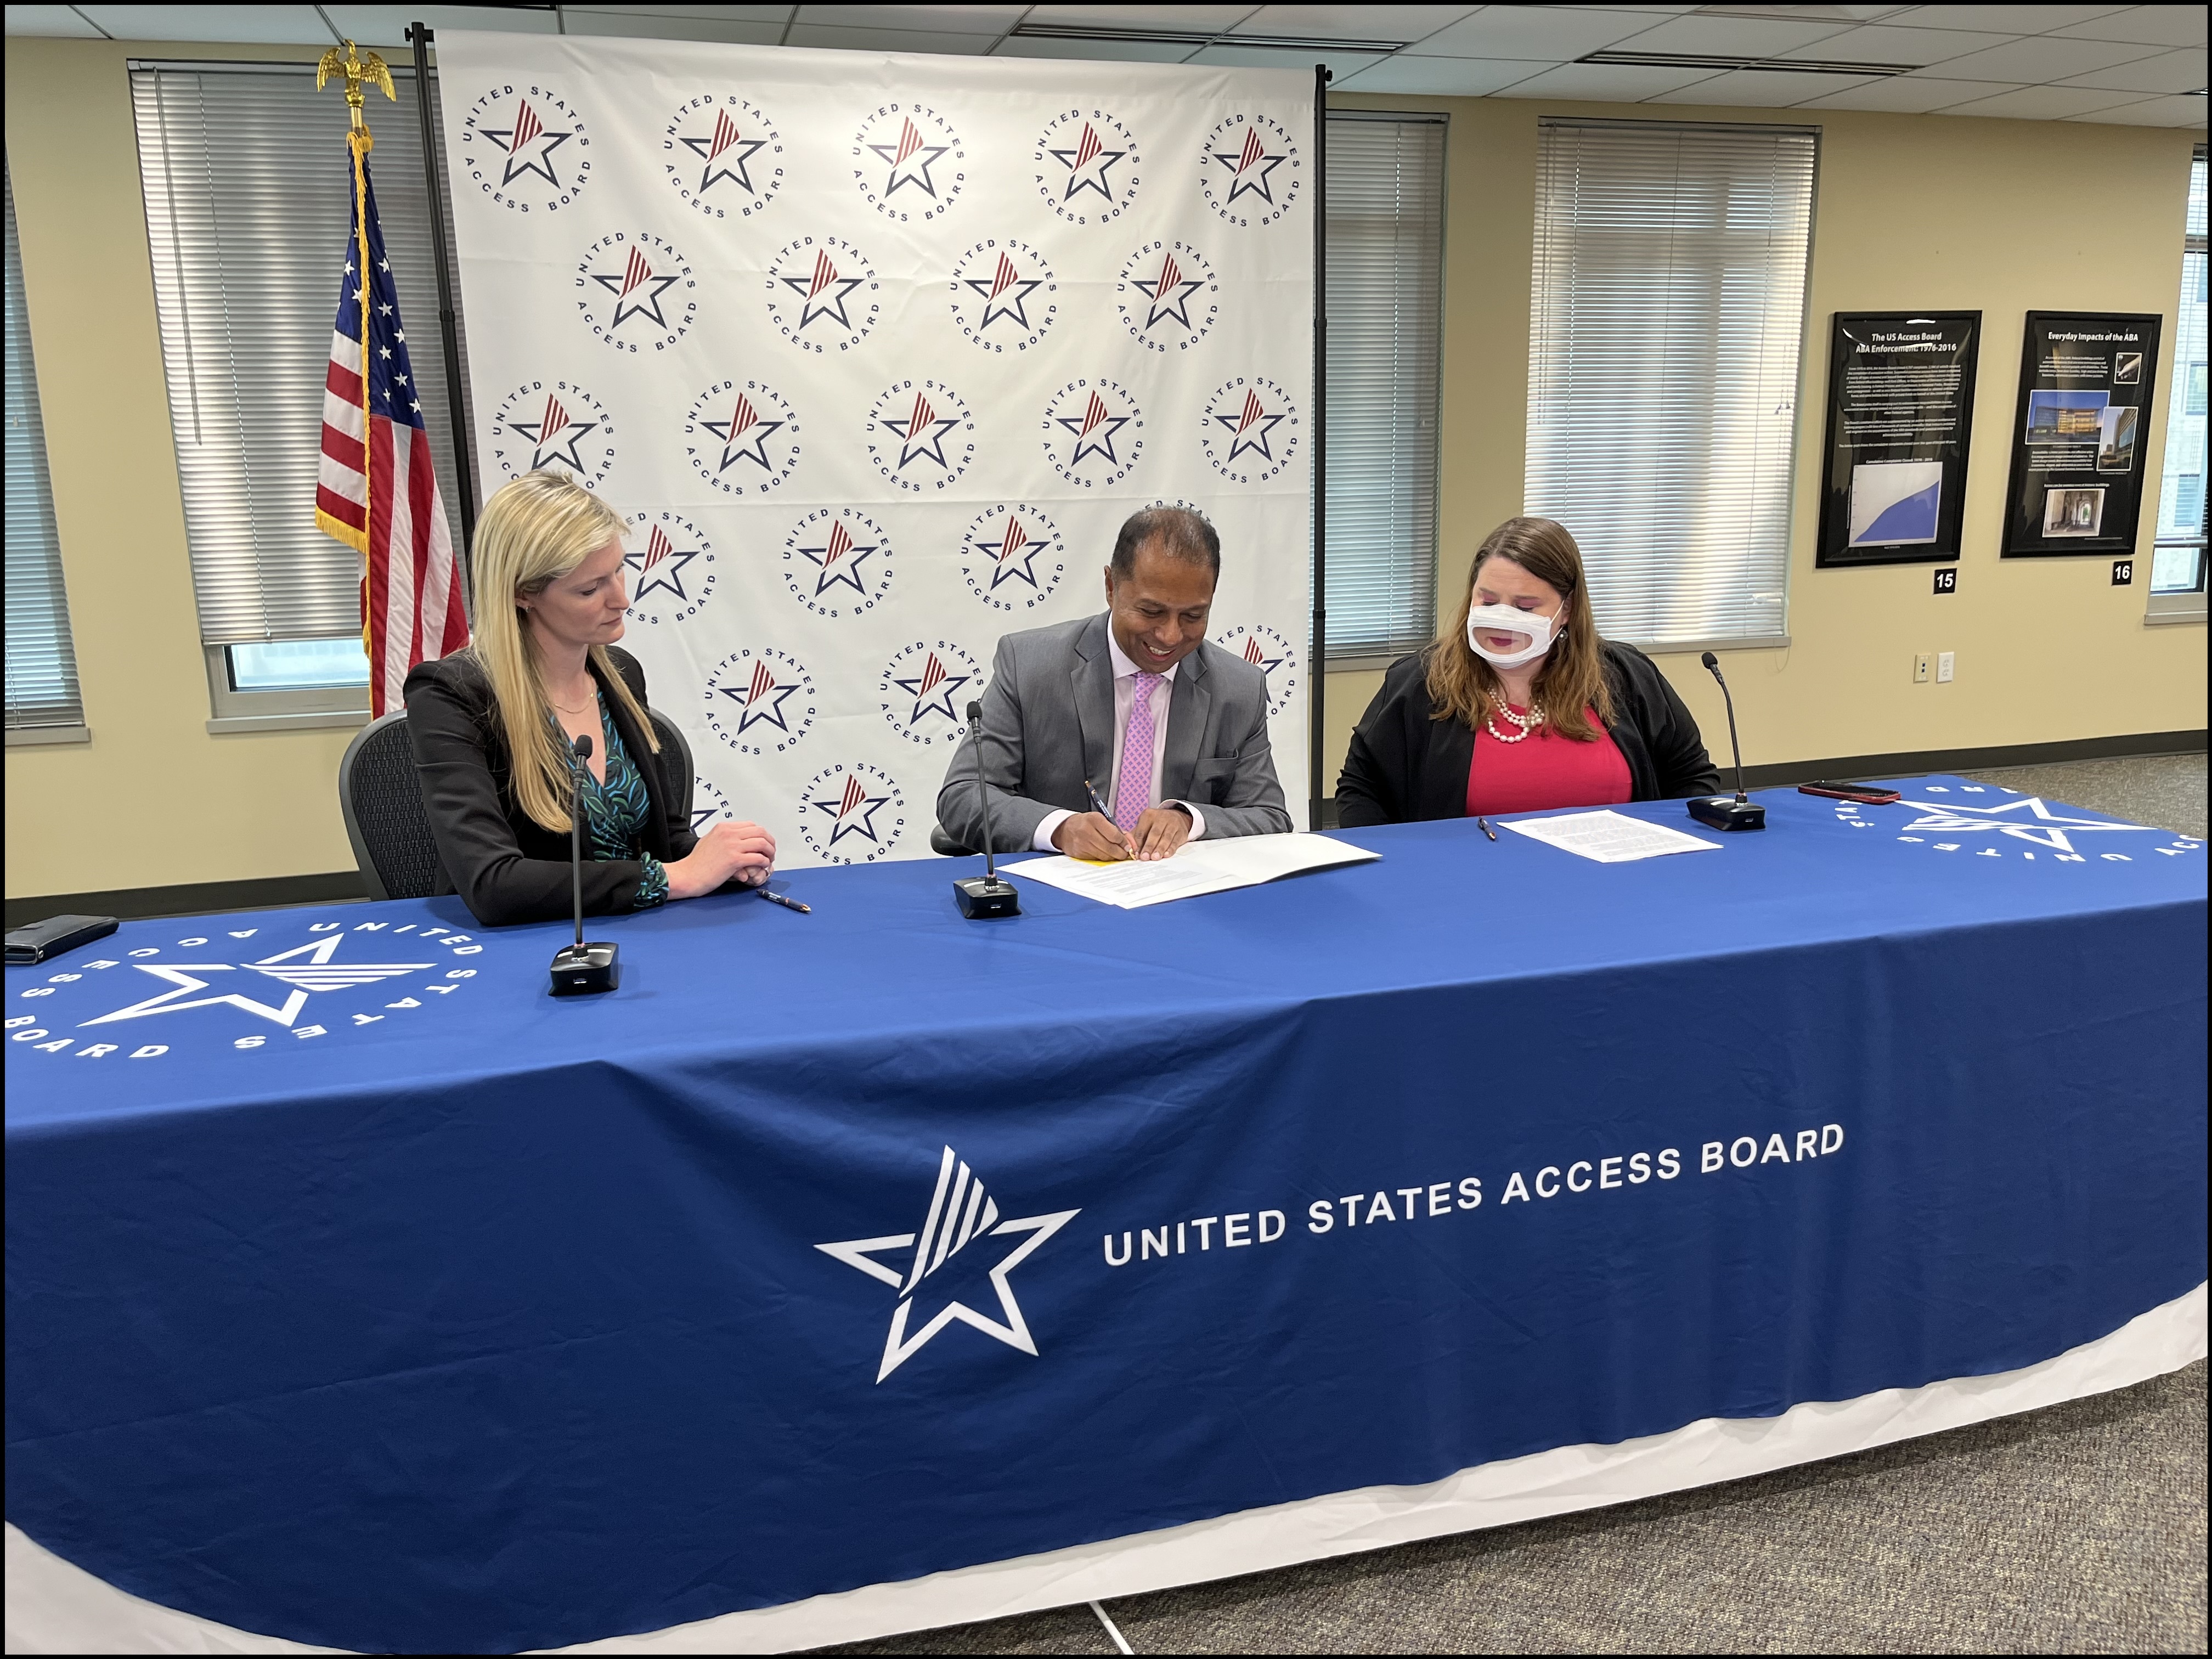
top-left (814, 1146), bottom-right (1082, 1383)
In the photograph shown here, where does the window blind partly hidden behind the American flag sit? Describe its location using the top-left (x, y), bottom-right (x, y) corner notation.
top-left (131, 64), bottom-right (467, 646)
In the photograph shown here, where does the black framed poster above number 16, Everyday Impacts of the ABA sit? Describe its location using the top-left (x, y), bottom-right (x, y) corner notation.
top-left (2002, 312), bottom-right (2161, 560)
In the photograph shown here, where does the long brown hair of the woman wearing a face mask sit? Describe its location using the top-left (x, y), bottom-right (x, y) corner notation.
top-left (1427, 517), bottom-right (1612, 743)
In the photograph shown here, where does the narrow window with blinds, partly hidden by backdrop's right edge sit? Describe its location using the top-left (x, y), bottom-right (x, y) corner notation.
top-left (1323, 113), bottom-right (1444, 666)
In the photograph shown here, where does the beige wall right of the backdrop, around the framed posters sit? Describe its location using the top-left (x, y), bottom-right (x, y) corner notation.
top-left (1325, 97), bottom-right (2205, 792)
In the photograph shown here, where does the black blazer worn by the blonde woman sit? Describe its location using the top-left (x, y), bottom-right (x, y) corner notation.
top-left (407, 650), bottom-right (699, 927)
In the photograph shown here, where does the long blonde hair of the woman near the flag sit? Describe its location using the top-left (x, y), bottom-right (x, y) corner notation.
top-left (469, 471), bottom-right (662, 832)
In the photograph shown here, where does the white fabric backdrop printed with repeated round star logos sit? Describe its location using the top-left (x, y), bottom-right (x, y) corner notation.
top-left (438, 31), bottom-right (1314, 867)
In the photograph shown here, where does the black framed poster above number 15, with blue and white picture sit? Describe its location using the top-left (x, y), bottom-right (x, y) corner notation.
top-left (1814, 312), bottom-right (1982, 568)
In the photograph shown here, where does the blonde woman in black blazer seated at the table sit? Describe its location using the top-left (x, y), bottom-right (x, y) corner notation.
top-left (407, 473), bottom-right (776, 927)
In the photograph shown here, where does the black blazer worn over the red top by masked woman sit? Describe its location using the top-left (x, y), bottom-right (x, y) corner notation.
top-left (1336, 639), bottom-right (1721, 830)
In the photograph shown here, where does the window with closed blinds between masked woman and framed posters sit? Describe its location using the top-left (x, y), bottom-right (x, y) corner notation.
top-left (1524, 120), bottom-right (1818, 650)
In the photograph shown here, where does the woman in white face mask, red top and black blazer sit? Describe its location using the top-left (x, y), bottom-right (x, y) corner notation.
top-left (1336, 517), bottom-right (1721, 830)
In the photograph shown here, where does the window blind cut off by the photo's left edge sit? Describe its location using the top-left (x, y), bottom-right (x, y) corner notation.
top-left (7, 151), bottom-right (84, 732)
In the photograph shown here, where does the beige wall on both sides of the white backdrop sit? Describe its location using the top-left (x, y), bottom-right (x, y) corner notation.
top-left (7, 38), bottom-right (2205, 898)
